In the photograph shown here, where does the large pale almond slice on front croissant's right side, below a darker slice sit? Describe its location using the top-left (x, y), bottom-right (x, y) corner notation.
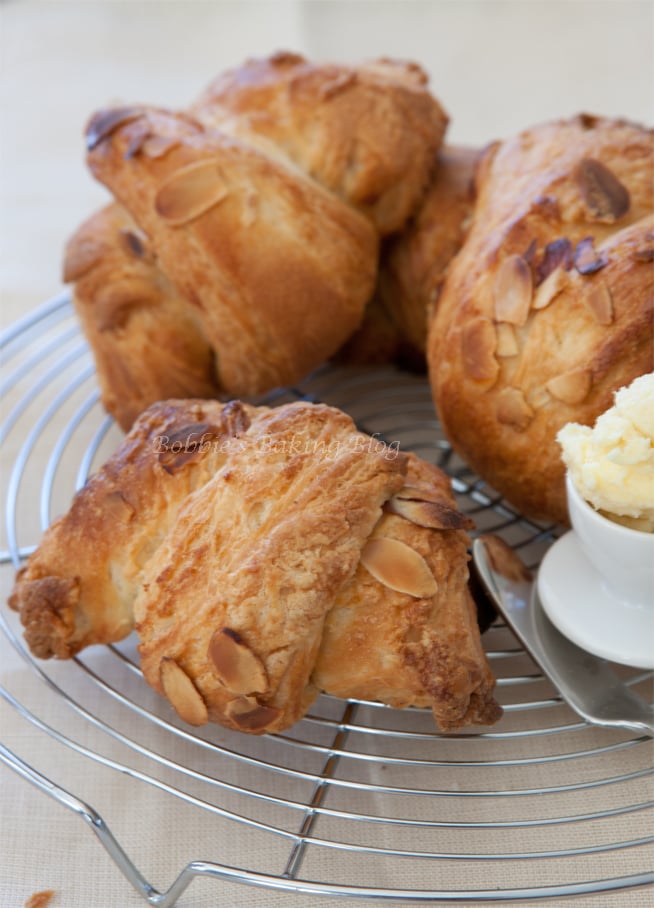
top-left (361, 536), bottom-right (438, 599)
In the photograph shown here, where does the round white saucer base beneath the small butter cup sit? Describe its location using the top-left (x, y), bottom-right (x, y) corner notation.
top-left (538, 531), bottom-right (654, 668)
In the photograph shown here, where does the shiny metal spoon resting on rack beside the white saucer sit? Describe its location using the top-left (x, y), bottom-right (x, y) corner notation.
top-left (472, 534), bottom-right (654, 736)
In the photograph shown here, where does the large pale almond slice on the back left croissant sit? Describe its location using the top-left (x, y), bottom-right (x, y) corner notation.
top-left (154, 161), bottom-right (229, 226)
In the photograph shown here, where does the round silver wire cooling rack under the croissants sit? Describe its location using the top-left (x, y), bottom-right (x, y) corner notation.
top-left (0, 295), bottom-right (653, 908)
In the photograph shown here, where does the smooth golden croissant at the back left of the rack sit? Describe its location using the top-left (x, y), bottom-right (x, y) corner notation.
top-left (64, 53), bottom-right (447, 429)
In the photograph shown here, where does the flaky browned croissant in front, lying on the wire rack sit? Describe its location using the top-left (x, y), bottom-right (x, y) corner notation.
top-left (10, 400), bottom-right (500, 734)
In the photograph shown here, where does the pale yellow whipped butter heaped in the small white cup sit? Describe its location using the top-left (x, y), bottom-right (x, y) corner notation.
top-left (557, 372), bottom-right (654, 533)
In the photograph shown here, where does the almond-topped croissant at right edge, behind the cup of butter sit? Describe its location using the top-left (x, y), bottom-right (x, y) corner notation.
top-left (428, 115), bottom-right (654, 523)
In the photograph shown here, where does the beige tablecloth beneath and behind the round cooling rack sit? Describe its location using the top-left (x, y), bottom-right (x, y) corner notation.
top-left (0, 0), bottom-right (654, 908)
